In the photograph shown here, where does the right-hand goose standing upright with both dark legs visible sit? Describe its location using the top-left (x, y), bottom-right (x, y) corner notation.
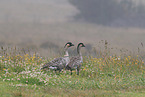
top-left (65, 43), bottom-right (85, 75)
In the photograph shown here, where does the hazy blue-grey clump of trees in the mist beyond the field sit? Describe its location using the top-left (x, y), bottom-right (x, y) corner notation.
top-left (69, 0), bottom-right (145, 27)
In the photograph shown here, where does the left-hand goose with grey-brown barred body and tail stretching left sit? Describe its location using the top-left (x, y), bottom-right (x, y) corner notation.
top-left (41, 42), bottom-right (74, 72)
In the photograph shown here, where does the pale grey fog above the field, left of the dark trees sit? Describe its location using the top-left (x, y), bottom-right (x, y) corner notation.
top-left (0, 0), bottom-right (75, 23)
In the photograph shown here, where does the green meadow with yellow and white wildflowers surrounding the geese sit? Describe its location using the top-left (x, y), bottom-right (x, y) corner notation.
top-left (0, 47), bottom-right (145, 97)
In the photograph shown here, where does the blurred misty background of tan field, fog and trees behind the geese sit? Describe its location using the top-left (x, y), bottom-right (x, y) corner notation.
top-left (0, 0), bottom-right (145, 57)
